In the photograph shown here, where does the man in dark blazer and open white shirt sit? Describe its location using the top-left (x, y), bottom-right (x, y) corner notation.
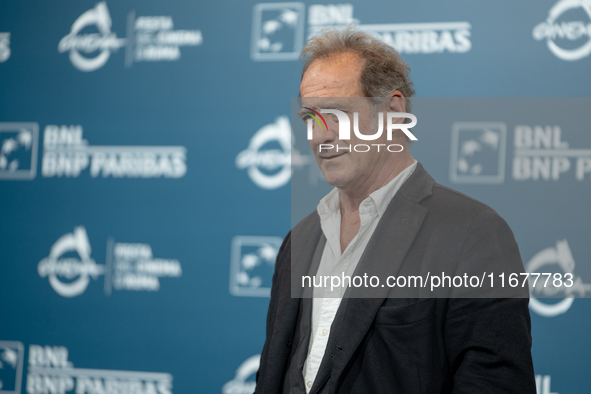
top-left (255, 28), bottom-right (536, 394)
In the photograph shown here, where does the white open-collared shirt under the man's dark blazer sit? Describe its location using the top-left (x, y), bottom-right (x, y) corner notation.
top-left (302, 160), bottom-right (417, 392)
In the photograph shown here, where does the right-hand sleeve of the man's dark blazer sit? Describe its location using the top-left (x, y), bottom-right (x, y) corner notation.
top-left (444, 208), bottom-right (536, 394)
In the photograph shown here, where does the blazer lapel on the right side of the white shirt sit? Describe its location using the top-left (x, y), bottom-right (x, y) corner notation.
top-left (310, 163), bottom-right (435, 394)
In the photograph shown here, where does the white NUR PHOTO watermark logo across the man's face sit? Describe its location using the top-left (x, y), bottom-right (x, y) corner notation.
top-left (300, 107), bottom-right (417, 153)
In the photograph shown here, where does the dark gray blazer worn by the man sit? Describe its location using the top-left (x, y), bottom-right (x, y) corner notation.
top-left (255, 163), bottom-right (536, 394)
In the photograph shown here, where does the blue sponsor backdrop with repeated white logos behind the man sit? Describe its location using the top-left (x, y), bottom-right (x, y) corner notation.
top-left (0, 0), bottom-right (591, 394)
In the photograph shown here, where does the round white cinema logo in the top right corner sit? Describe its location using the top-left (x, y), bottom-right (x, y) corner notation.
top-left (532, 0), bottom-right (591, 61)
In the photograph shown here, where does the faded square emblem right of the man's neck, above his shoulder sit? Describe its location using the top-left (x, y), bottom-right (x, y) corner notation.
top-left (450, 122), bottom-right (507, 183)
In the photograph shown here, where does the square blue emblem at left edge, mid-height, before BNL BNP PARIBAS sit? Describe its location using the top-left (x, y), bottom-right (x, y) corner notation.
top-left (0, 123), bottom-right (39, 180)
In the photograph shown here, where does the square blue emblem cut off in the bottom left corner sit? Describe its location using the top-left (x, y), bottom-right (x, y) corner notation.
top-left (0, 341), bottom-right (25, 394)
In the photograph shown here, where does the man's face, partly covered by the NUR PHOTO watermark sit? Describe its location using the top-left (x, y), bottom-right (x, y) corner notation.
top-left (300, 53), bottom-right (396, 191)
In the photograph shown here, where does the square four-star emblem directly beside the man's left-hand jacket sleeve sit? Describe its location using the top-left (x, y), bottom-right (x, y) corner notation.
top-left (230, 235), bottom-right (283, 297)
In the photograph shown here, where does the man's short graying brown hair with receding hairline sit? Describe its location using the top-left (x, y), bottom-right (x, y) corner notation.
top-left (301, 26), bottom-right (415, 112)
